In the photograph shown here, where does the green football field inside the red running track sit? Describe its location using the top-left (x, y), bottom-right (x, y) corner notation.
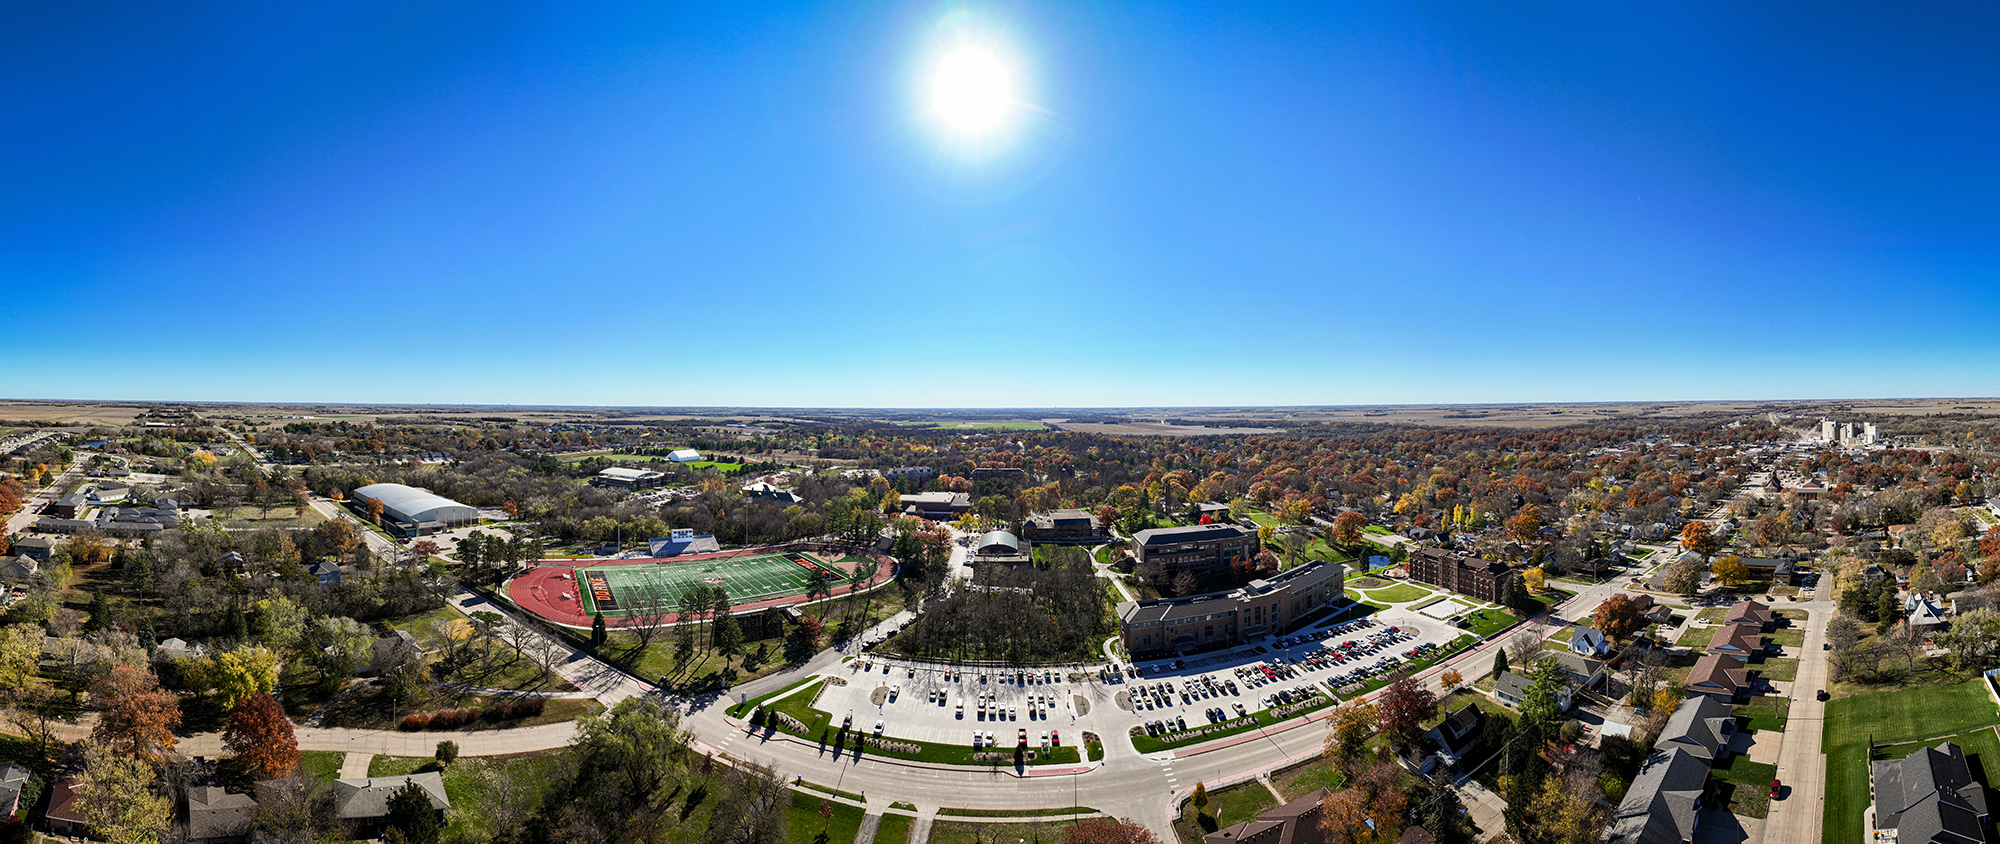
top-left (576, 554), bottom-right (848, 616)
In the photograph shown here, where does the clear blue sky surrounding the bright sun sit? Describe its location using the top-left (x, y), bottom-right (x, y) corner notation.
top-left (0, 2), bottom-right (2000, 406)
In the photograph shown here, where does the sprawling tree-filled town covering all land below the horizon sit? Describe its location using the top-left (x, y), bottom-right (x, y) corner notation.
top-left (0, 402), bottom-right (2000, 844)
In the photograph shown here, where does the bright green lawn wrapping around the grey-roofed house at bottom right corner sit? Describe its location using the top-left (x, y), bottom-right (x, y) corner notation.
top-left (1820, 680), bottom-right (2000, 842)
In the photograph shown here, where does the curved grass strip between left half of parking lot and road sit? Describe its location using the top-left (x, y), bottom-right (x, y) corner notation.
top-left (748, 678), bottom-right (1082, 768)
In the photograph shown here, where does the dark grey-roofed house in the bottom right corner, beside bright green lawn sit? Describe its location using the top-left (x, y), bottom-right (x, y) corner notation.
top-left (1870, 742), bottom-right (1990, 844)
